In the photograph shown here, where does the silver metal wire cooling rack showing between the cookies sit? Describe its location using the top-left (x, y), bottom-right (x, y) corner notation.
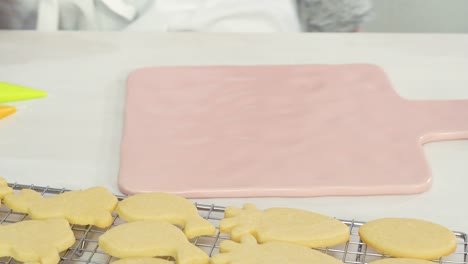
top-left (0, 184), bottom-right (468, 264)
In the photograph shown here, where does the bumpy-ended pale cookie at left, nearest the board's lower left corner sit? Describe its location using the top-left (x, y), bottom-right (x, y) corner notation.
top-left (4, 187), bottom-right (118, 228)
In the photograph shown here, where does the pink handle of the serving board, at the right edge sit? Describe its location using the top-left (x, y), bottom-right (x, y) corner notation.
top-left (414, 100), bottom-right (468, 144)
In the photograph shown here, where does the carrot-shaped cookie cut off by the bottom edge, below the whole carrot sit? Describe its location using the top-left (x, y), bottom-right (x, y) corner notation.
top-left (211, 235), bottom-right (343, 264)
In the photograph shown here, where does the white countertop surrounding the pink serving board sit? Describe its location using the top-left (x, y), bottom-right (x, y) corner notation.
top-left (0, 31), bottom-right (468, 232)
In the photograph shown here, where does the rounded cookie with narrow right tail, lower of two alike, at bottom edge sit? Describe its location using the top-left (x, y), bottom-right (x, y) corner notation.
top-left (99, 220), bottom-right (210, 264)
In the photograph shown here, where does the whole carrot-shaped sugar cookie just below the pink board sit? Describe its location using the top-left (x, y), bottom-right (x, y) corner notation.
top-left (219, 204), bottom-right (349, 248)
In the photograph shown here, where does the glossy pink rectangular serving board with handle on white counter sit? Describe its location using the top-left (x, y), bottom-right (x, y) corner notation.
top-left (119, 64), bottom-right (468, 197)
